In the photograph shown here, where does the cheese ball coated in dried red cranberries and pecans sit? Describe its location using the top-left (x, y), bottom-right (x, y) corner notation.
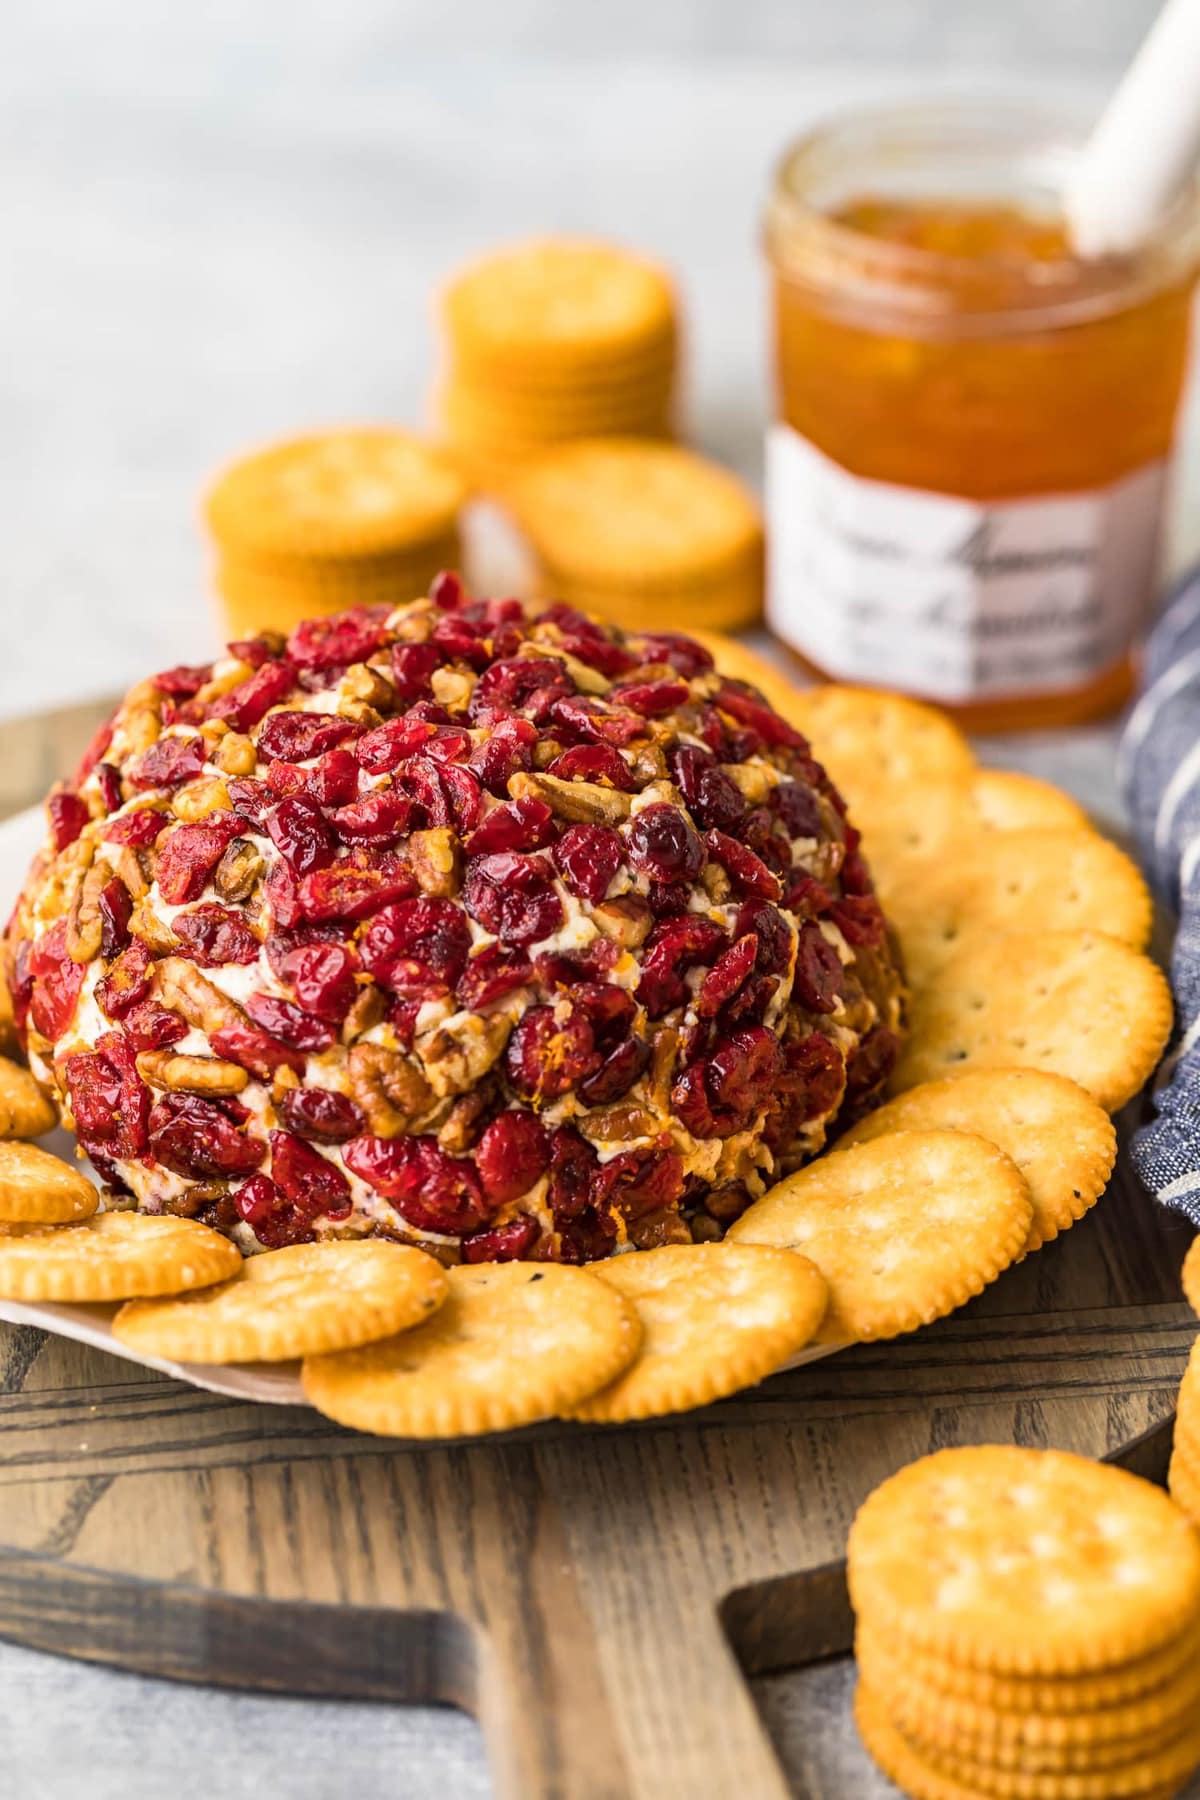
top-left (5, 576), bottom-right (903, 1264)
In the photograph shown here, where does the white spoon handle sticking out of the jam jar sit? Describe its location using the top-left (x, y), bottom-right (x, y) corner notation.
top-left (1063, 0), bottom-right (1200, 256)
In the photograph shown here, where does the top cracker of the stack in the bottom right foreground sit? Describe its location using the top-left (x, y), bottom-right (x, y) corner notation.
top-left (847, 1444), bottom-right (1200, 1674)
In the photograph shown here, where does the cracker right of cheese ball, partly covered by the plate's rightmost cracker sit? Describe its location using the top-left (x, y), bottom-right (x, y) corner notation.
top-left (887, 830), bottom-right (1153, 986)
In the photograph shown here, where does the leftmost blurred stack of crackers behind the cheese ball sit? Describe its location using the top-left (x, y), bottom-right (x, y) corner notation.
top-left (205, 428), bottom-right (466, 639)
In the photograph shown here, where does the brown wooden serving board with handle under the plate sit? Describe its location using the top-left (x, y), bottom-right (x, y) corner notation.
top-left (0, 694), bottom-right (1195, 1800)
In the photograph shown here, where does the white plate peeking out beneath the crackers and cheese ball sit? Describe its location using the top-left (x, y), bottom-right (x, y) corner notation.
top-left (0, 806), bottom-right (840, 1406)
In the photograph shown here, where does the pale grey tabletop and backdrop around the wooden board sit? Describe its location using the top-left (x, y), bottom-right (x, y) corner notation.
top-left (0, 0), bottom-right (1200, 1800)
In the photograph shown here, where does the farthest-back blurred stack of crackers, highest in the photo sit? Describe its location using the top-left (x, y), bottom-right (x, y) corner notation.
top-left (434, 238), bottom-right (678, 486)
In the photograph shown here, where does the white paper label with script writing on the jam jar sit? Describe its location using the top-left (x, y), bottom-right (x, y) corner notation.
top-left (766, 425), bottom-right (1168, 700)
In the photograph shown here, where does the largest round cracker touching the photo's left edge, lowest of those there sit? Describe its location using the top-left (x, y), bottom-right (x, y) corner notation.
top-left (0, 1213), bottom-right (241, 1301)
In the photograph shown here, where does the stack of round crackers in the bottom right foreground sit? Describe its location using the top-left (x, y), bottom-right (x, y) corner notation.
top-left (847, 1445), bottom-right (1200, 1800)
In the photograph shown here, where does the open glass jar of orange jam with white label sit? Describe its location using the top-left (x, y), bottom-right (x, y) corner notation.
top-left (766, 103), bottom-right (1200, 731)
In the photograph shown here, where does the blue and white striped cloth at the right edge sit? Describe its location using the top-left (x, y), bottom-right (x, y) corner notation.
top-left (1119, 569), bottom-right (1200, 1228)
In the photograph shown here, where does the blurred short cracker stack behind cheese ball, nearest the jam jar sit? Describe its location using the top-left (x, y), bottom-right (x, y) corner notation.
top-left (506, 437), bottom-right (763, 632)
